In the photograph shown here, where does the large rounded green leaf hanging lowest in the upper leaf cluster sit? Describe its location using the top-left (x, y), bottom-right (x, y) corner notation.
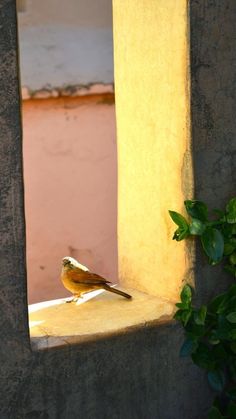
top-left (201, 227), bottom-right (224, 263)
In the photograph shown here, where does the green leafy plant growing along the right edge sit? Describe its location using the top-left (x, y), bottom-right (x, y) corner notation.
top-left (169, 198), bottom-right (236, 419)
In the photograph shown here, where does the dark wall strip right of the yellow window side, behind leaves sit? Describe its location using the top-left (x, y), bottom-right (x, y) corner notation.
top-left (190, 0), bottom-right (236, 301)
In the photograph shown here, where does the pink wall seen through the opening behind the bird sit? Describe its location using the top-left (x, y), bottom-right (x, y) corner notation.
top-left (23, 95), bottom-right (117, 303)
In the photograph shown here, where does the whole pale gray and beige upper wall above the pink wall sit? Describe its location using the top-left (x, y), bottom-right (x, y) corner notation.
top-left (18, 0), bottom-right (113, 95)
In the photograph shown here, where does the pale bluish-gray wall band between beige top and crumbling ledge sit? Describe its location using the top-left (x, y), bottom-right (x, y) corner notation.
top-left (20, 25), bottom-right (113, 91)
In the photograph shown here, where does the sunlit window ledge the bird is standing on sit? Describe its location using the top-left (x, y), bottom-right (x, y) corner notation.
top-left (29, 289), bottom-right (175, 350)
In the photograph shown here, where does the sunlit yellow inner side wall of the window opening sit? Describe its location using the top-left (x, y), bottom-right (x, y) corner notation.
top-left (113, 0), bottom-right (192, 299)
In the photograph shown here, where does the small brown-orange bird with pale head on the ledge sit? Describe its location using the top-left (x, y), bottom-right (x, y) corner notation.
top-left (61, 256), bottom-right (132, 302)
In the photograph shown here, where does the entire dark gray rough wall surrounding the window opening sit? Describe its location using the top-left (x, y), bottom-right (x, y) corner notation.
top-left (0, 0), bottom-right (236, 419)
